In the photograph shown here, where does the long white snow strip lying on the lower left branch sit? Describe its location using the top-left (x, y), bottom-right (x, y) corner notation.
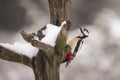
top-left (0, 42), bottom-right (39, 58)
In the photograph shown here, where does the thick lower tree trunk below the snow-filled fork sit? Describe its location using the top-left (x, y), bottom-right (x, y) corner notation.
top-left (32, 51), bottom-right (60, 80)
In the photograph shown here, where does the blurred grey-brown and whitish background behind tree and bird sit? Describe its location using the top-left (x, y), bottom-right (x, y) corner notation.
top-left (0, 0), bottom-right (120, 80)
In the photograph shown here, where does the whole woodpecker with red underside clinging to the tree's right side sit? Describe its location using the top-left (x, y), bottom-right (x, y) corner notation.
top-left (62, 27), bottom-right (89, 67)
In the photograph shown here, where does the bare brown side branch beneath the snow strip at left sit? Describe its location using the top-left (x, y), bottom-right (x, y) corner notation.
top-left (0, 45), bottom-right (32, 67)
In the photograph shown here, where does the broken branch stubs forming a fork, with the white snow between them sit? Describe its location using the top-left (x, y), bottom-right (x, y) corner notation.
top-left (21, 20), bottom-right (71, 63)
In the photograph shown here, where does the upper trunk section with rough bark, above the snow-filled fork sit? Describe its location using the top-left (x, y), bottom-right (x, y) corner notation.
top-left (48, 0), bottom-right (71, 25)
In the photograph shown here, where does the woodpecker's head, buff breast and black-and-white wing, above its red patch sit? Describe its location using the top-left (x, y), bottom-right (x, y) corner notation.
top-left (68, 27), bottom-right (89, 57)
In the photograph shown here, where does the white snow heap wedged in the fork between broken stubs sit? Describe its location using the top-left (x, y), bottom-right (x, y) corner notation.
top-left (41, 21), bottom-right (66, 47)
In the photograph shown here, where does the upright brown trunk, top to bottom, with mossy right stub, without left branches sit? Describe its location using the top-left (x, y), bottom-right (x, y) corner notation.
top-left (32, 0), bottom-right (70, 80)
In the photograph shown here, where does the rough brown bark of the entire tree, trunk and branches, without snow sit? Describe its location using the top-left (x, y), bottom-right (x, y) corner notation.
top-left (0, 0), bottom-right (71, 80)
